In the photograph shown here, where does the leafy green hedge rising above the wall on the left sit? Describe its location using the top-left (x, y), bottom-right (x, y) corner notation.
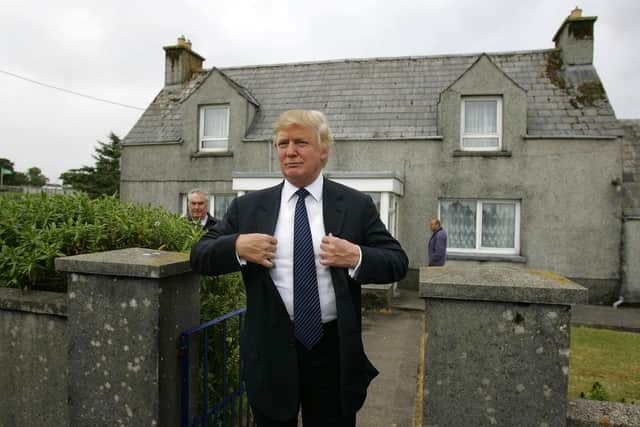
top-left (0, 193), bottom-right (202, 291)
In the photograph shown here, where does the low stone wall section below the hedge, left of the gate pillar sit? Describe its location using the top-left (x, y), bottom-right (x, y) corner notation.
top-left (0, 288), bottom-right (69, 427)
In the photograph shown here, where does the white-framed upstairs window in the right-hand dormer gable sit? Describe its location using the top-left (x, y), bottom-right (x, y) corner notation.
top-left (460, 96), bottom-right (502, 151)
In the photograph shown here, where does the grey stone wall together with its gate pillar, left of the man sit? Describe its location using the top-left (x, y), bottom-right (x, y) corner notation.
top-left (0, 248), bottom-right (200, 427)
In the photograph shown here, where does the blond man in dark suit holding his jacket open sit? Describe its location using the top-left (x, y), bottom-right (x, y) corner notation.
top-left (191, 110), bottom-right (408, 427)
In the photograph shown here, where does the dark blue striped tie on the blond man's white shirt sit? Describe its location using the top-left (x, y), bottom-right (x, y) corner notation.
top-left (293, 188), bottom-right (322, 350)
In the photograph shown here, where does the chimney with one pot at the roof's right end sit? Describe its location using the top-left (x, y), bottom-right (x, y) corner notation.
top-left (553, 6), bottom-right (598, 65)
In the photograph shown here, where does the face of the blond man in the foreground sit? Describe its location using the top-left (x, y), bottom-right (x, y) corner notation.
top-left (276, 125), bottom-right (329, 188)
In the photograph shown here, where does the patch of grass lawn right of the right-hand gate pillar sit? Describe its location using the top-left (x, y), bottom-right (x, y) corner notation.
top-left (569, 327), bottom-right (640, 404)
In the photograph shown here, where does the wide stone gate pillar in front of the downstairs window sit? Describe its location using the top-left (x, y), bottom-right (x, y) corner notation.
top-left (420, 262), bottom-right (587, 427)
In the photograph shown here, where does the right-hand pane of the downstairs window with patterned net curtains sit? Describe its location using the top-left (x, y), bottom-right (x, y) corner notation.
top-left (482, 202), bottom-right (516, 248)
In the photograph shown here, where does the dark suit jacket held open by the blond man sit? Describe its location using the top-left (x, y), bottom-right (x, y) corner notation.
top-left (191, 179), bottom-right (408, 419)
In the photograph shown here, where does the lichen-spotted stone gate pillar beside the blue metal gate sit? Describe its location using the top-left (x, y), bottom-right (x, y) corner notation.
top-left (56, 248), bottom-right (200, 427)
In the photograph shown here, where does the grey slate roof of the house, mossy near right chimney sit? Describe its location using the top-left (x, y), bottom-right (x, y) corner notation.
top-left (124, 49), bottom-right (622, 144)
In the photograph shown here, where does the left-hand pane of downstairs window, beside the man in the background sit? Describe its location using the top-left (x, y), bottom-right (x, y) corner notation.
top-left (440, 200), bottom-right (476, 249)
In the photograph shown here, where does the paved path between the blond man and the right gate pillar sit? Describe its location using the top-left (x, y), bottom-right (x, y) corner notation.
top-left (357, 309), bottom-right (424, 427)
